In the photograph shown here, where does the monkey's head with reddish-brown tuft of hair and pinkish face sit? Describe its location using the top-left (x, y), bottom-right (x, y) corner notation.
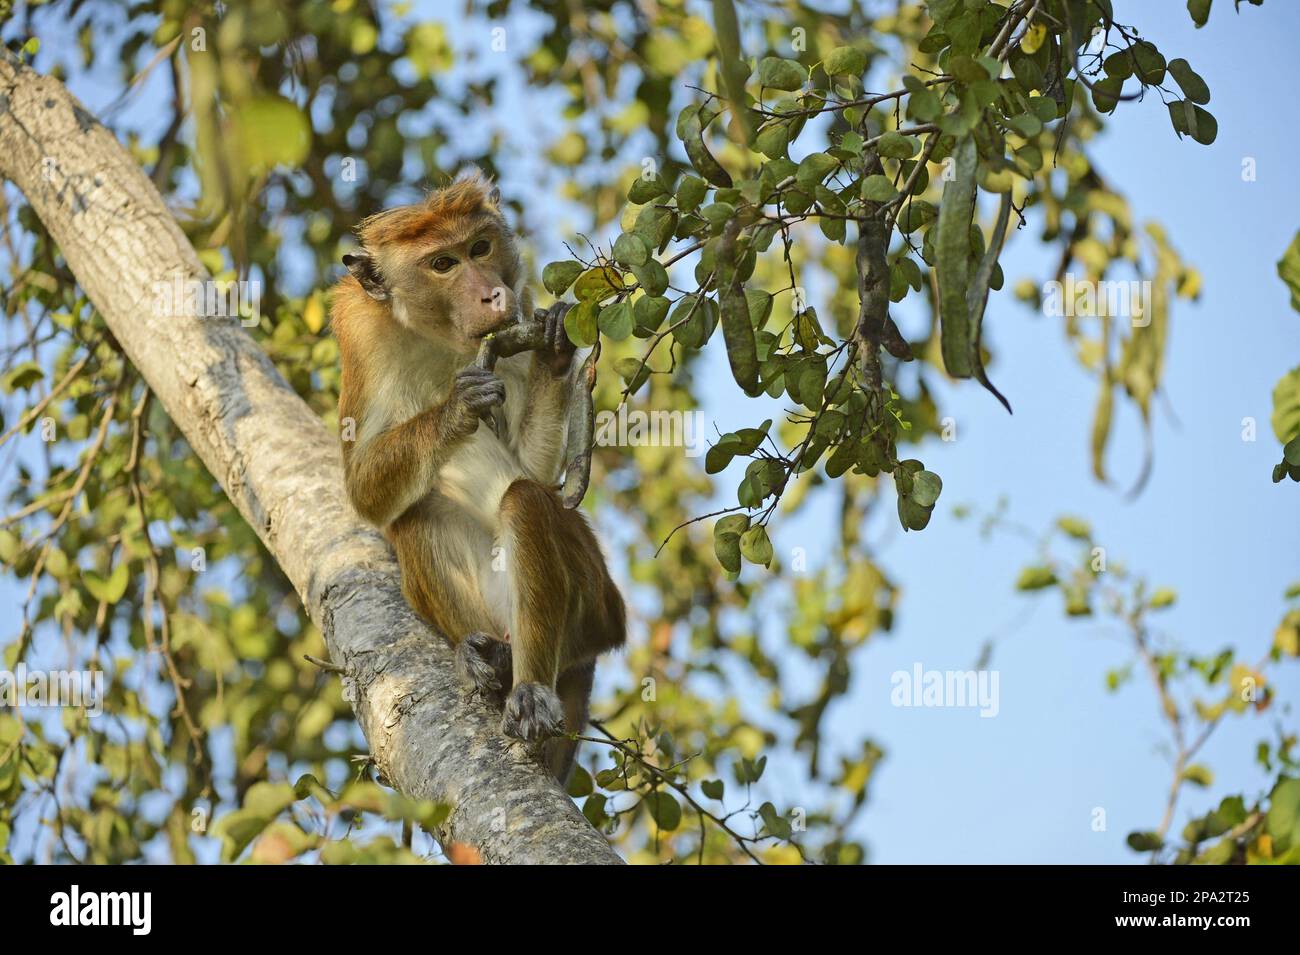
top-left (343, 170), bottom-right (520, 355)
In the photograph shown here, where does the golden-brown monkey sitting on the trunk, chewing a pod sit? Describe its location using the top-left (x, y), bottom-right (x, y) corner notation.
top-left (330, 170), bottom-right (627, 783)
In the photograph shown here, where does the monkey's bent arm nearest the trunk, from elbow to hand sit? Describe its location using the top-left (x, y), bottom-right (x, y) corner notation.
top-left (343, 368), bottom-right (506, 528)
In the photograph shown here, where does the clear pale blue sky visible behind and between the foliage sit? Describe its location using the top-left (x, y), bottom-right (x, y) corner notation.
top-left (0, 0), bottom-right (1300, 863)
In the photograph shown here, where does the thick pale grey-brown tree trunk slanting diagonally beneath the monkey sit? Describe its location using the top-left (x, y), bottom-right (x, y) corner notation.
top-left (0, 49), bottom-right (620, 863)
